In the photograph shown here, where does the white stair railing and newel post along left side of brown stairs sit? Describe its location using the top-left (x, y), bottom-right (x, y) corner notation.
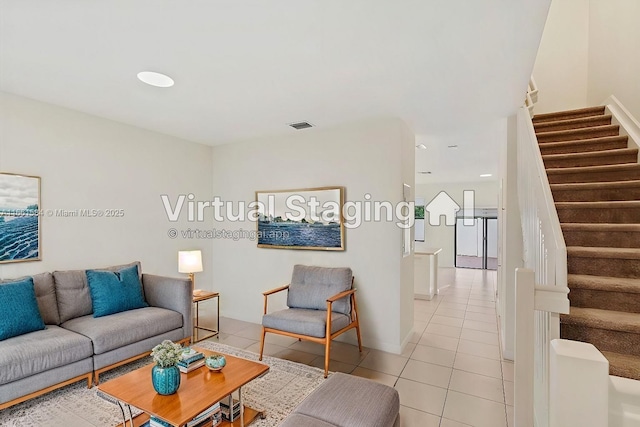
top-left (514, 79), bottom-right (569, 427)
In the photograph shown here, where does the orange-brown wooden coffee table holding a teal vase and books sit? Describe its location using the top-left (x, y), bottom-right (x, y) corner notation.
top-left (98, 348), bottom-right (269, 427)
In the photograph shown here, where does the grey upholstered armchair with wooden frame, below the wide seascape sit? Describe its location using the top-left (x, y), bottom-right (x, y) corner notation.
top-left (260, 265), bottom-right (362, 378)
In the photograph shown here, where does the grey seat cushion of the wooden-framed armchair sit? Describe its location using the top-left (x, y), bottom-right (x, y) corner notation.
top-left (262, 308), bottom-right (349, 338)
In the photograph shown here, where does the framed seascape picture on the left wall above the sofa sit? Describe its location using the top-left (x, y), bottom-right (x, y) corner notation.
top-left (0, 172), bottom-right (42, 264)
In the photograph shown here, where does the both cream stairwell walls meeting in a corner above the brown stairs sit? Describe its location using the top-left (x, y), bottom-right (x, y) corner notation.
top-left (533, 0), bottom-right (640, 119)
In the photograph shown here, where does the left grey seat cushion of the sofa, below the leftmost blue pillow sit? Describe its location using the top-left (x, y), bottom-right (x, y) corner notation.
top-left (0, 325), bottom-right (93, 384)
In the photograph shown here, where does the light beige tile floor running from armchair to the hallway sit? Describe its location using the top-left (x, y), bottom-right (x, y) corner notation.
top-left (200, 268), bottom-right (513, 427)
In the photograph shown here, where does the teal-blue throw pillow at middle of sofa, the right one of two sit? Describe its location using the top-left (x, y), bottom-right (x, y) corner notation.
top-left (87, 265), bottom-right (149, 317)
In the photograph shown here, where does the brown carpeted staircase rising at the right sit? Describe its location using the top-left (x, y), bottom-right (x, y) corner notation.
top-left (533, 107), bottom-right (640, 380)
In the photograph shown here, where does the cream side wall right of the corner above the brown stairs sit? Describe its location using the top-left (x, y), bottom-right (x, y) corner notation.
top-left (588, 0), bottom-right (640, 119)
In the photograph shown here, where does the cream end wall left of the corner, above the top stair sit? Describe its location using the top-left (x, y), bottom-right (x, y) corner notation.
top-left (533, 0), bottom-right (592, 114)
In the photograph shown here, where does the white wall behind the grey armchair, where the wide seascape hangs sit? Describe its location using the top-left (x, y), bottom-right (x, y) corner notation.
top-left (212, 119), bottom-right (415, 352)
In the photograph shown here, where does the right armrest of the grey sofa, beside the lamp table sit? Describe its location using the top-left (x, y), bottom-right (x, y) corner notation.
top-left (142, 274), bottom-right (193, 338)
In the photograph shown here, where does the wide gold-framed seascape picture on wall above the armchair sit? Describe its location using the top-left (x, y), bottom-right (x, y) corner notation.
top-left (256, 187), bottom-right (345, 251)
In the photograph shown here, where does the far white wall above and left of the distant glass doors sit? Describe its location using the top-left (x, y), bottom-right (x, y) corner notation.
top-left (416, 180), bottom-right (498, 267)
